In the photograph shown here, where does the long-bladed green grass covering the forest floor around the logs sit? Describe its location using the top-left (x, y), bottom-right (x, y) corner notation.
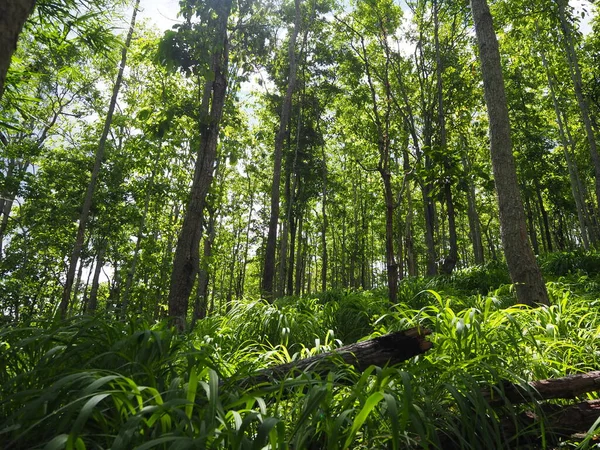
top-left (0, 267), bottom-right (600, 450)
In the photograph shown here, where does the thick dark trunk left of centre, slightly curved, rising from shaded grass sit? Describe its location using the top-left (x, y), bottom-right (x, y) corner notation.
top-left (169, 0), bottom-right (232, 331)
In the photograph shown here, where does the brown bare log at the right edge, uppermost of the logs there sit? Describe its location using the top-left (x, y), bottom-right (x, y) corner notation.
top-left (484, 371), bottom-right (600, 405)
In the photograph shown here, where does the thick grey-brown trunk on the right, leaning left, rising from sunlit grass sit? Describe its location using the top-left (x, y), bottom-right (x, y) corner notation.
top-left (471, 0), bottom-right (548, 305)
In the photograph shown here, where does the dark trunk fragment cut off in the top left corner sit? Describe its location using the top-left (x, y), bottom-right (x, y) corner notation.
top-left (0, 0), bottom-right (35, 99)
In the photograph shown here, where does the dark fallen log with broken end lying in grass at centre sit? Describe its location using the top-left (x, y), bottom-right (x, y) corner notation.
top-left (238, 327), bottom-right (433, 387)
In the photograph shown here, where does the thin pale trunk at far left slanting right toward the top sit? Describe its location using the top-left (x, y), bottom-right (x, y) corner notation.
top-left (59, 0), bottom-right (140, 319)
